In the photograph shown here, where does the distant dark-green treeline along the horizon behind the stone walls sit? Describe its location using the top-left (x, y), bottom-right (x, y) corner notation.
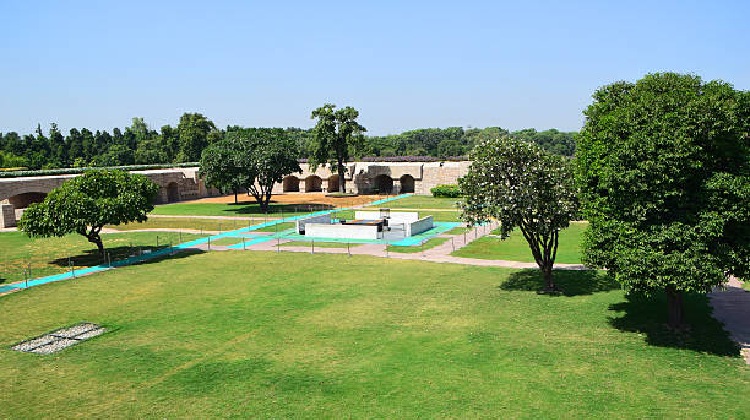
top-left (0, 113), bottom-right (575, 170)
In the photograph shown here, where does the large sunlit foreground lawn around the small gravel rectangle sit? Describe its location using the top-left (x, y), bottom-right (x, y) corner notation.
top-left (0, 251), bottom-right (750, 418)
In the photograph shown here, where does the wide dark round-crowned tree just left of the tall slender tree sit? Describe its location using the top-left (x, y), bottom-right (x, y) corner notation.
top-left (201, 127), bottom-right (302, 209)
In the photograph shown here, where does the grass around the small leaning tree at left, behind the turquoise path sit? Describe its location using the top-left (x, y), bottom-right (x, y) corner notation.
top-left (0, 232), bottom-right (199, 283)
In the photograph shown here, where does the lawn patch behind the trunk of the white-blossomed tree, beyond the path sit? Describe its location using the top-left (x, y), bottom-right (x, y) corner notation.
top-left (452, 222), bottom-right (586, 264)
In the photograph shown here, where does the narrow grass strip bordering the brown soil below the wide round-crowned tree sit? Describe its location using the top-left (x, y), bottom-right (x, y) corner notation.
top-left (152, 201), bottom-right (332, 217)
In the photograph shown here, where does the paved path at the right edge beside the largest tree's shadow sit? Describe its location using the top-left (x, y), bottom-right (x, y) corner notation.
top-left (708, 277), bottom-right (750, 364)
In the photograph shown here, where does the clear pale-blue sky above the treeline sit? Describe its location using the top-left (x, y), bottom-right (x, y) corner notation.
top-left (0, 0), bottom-right (750, 135)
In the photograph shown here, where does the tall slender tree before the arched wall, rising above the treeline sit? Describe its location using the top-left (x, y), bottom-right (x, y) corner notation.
top-left (309, 104), bottom-right (367, 193)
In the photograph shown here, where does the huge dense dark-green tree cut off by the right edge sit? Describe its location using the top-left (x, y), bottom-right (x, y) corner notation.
top-left (577, 73), bottom-right (750, 328)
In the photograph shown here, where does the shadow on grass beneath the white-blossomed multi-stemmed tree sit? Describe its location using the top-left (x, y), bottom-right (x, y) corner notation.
top-left (500, 269), bottom-right (620, 296)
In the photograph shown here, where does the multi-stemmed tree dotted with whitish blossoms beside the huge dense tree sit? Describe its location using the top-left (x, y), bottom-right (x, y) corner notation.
top-left (459, 136), bottom-right (577, 292)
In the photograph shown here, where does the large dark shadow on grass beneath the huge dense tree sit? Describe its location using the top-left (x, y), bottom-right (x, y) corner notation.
top-left (609, 293), bottom-right (740, 357)
